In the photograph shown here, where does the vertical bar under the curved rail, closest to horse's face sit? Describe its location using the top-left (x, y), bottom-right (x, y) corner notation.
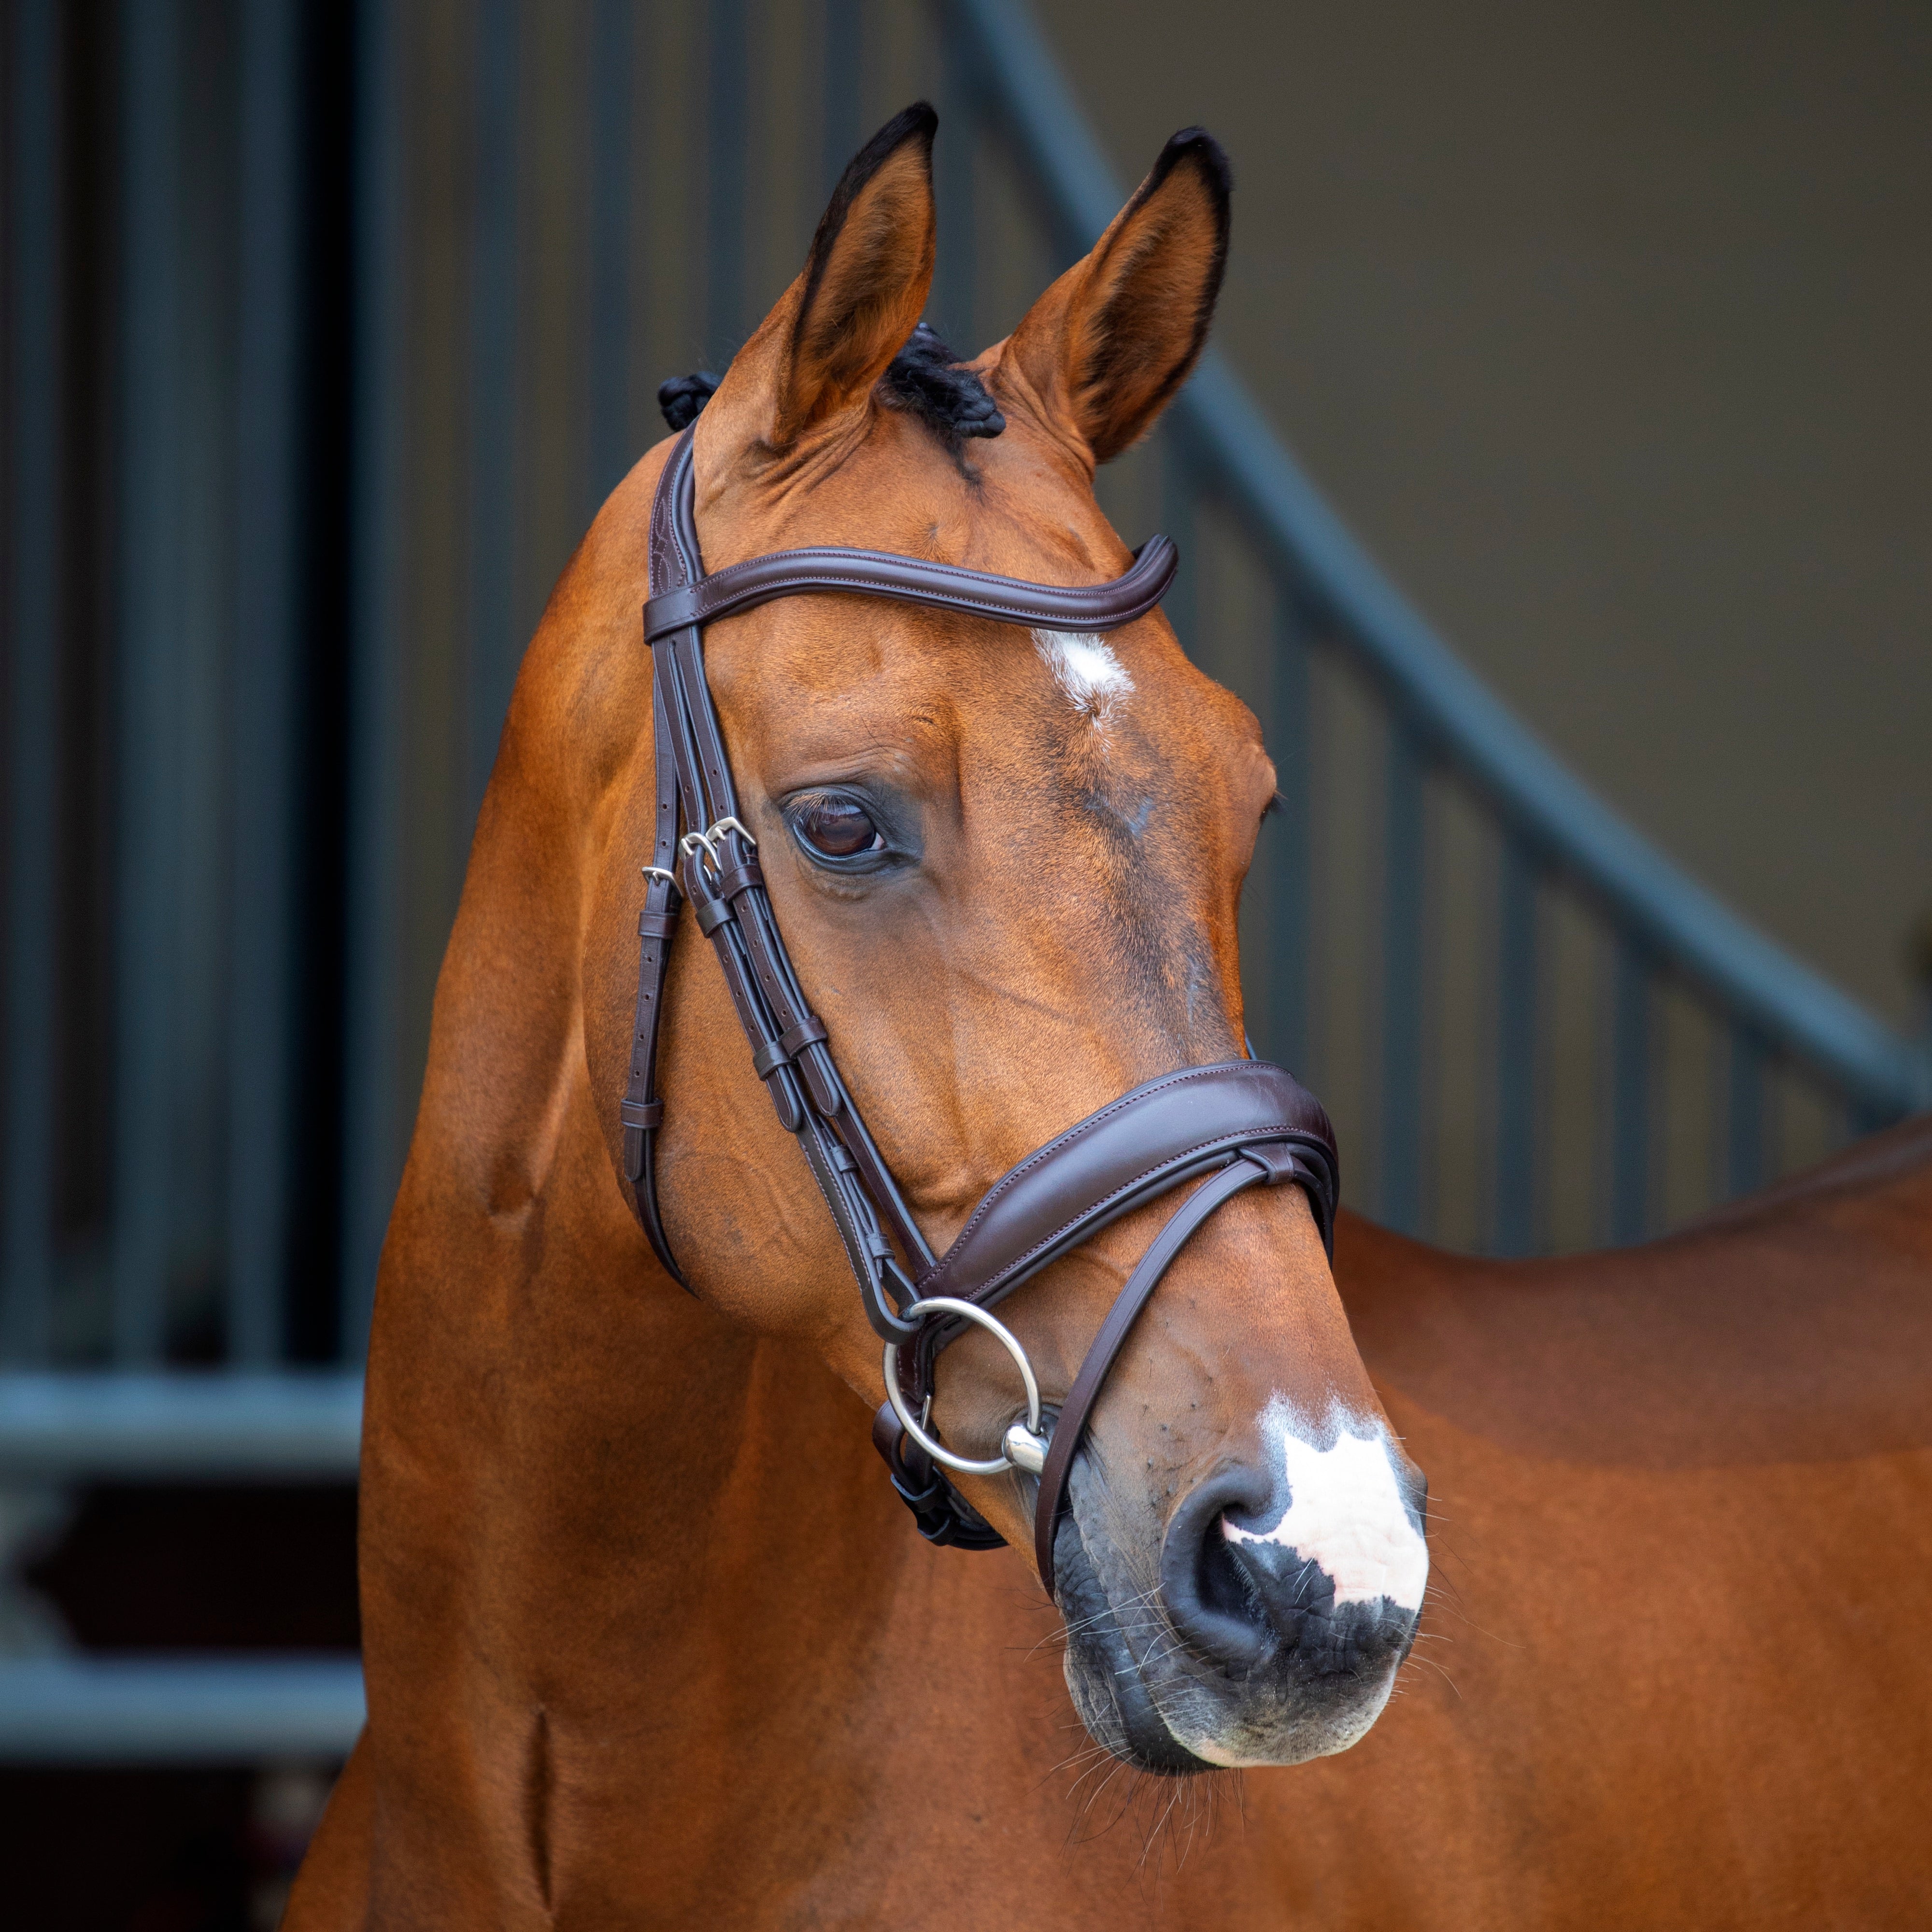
top-left (1265, 603), bottom-right (1314, 1082)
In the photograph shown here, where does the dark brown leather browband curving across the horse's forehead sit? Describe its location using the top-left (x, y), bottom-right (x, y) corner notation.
top-left (643, 537), bottom-right (1180, 643)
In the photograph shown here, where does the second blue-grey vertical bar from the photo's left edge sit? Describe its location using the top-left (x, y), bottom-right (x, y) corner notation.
top-left (112, 0), bottom-right (184, 1362)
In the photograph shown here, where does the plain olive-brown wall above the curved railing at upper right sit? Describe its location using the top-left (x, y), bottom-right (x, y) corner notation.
top-left (1037, 0), bottom-right (1932, 1022)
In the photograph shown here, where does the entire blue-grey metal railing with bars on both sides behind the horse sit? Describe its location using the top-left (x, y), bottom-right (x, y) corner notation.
top-left (0, 0), bottom-right (1932, 1758)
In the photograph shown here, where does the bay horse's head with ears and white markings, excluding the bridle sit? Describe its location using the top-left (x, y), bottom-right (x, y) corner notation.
top-left (585, 108), bottom-right (1428, 1772)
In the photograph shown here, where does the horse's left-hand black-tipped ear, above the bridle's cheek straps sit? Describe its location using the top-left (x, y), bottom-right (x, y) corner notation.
top-left (705, 100), bottom-right (939, 448)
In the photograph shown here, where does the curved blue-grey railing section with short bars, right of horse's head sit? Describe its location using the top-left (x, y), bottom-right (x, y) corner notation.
top-left (951, 0), bottom-right (1932, 1254)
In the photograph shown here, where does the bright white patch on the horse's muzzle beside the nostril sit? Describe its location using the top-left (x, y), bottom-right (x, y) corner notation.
top-left (1221, 1395), bottom-right (1430, 1609)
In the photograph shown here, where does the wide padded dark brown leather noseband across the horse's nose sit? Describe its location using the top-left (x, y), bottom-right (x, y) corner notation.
top-left (918, 1061), bottom-right (1341, 1306)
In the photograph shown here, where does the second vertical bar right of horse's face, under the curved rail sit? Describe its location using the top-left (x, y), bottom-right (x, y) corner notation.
top-left (1376, 711), bottom-right (1424, 1235)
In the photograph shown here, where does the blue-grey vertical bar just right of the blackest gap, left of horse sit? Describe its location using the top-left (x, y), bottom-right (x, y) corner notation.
top-left (340, 0), bottom-right (404, 1362)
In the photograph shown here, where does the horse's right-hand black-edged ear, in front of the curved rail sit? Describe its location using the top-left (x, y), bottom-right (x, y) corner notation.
top-left (1003, 128), bottom-right (1233, 464)
